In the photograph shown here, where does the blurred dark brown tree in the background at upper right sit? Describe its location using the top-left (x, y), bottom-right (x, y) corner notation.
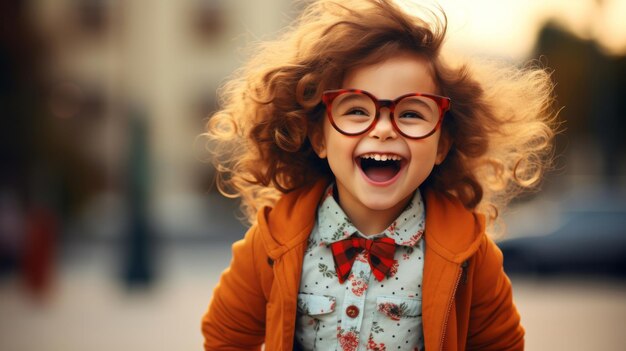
top-left (535, 23), bottom-right (626, 186)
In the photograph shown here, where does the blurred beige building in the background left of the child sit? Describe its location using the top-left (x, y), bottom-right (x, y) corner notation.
top-left (22, 0), bottom-right (301, 242)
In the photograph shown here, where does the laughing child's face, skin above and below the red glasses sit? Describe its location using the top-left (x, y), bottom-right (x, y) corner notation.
top-left (316, 53), bottom-right (447, 224)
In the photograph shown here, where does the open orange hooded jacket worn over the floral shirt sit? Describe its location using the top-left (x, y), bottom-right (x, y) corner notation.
top-left (202, 182), bottom-right (524, 351)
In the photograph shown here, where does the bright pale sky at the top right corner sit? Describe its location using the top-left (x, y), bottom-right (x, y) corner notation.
top-left (414, 0), bottom-right (626, 60)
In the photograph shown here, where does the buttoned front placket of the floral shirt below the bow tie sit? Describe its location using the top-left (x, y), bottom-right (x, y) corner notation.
top-left (337, 254), bottom-right (372, 350)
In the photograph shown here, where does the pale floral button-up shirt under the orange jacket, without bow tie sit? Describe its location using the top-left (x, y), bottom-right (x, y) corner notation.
top-left (295, 186), bottom-right (425, 351)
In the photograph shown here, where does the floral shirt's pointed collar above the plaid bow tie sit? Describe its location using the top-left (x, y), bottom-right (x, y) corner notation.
top-left (317, 184), bottom-right (425, 246)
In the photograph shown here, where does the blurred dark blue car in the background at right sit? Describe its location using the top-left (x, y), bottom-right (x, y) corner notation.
top-left (498, 195), bottom-right (626, 279)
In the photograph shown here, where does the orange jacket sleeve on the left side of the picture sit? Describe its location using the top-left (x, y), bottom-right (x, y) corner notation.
top-left (202, 226), bottom-right (266, 350)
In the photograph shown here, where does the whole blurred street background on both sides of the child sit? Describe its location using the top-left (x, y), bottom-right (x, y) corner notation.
top-left (0, 0), bottom-right (626, 351)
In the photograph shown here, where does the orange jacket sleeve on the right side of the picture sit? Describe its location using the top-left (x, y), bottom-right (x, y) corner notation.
top-left (467, 235), bottom-right (524, 350)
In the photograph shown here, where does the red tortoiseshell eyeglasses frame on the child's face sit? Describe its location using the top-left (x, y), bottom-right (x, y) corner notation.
top-left (322, 89), bottom-right (451, 140)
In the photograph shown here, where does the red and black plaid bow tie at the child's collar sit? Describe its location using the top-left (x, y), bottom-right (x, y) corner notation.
top-left (330, 236), bottom-right (396, 283)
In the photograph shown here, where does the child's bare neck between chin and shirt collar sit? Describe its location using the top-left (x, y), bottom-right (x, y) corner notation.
top-left (335, 187), bottom-right (413, 236)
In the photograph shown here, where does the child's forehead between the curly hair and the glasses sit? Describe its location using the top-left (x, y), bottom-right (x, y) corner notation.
top-left (341, 52), bottom-right (438, 99)
